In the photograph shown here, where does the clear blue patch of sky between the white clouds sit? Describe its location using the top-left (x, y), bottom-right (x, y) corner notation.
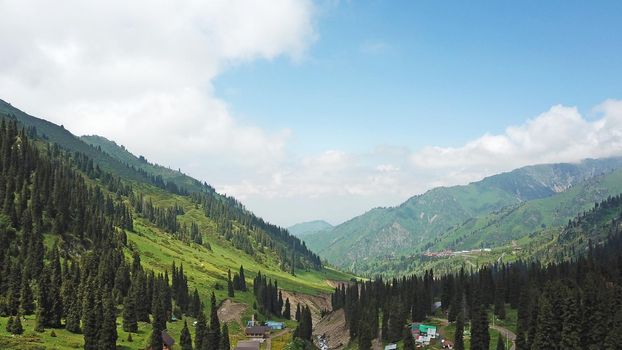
top-left (215, 1), bottom-right (622, 152)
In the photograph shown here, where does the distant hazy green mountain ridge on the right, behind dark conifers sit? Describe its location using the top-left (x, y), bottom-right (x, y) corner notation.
top-left (305, 158), bottom-right (622, 272)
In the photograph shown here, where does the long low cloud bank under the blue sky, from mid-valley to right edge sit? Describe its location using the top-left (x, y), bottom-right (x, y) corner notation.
top-left (224, 100), bottom-right (622, 223)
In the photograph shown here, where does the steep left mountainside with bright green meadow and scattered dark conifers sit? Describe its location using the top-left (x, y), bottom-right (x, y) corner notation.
top-left (0, 101), bottom-right (353, 349)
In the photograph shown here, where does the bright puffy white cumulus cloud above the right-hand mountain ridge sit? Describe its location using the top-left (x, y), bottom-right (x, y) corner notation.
top-left (412, 100), bottom-right (622, 183)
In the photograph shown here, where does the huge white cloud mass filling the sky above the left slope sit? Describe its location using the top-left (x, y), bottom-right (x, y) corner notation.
top-left (0, 0), bottom-right (316, 179)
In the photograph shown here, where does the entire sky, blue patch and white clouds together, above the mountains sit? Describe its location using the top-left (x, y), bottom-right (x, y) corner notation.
top-left (0, 0), bottom-right (622, 226)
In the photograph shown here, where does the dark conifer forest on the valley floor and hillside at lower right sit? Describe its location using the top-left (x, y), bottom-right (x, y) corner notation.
top-left (332, 196), bottom-right (622, 350)
